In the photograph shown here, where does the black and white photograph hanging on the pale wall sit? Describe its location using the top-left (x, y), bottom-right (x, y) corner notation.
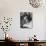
top-left (20, 12), bottom-right (33, 28)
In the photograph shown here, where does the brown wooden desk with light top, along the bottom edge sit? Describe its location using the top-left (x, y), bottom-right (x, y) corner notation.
top-left (5, 40), bottom-right (46, 46)
